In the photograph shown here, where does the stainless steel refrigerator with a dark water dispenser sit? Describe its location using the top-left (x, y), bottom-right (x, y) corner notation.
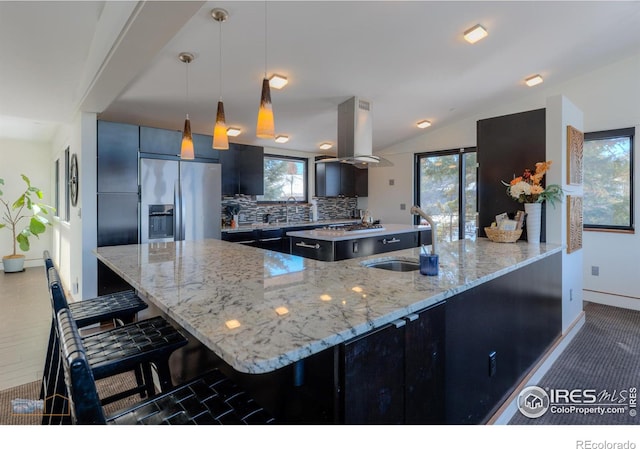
top-left (140, 158), bottom-right (221, 243)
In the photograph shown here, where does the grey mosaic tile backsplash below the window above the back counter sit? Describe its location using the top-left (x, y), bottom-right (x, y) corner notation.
top-left (222, 195), bottom-right (358, 225)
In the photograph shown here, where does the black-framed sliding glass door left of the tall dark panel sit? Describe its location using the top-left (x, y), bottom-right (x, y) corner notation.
top-left (416, 148), bottom-right (478, 241)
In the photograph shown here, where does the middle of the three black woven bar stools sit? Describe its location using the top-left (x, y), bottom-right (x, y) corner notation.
top-left (42, 267), bottom-right (187, 424)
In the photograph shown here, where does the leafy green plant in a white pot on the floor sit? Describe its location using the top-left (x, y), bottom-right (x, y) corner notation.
top-left (0, 175), bottom-right (54, 273)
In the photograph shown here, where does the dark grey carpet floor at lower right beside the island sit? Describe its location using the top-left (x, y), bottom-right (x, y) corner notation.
top-left (509, 303), bottom-right (640, 425)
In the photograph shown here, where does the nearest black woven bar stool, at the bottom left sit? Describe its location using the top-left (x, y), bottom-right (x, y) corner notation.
top-left (57, 309), bottom-right (274, 424)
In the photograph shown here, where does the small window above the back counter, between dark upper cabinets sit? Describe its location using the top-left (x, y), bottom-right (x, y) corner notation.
top-left (257, 154), bottom-right (307, 203)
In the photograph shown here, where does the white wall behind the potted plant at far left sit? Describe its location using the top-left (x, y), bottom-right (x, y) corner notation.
top-left (0, 139), bottom-right (54, 268)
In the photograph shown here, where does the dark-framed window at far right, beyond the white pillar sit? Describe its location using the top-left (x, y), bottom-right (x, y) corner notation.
top-left (583, 128), bottom-right (635, 232)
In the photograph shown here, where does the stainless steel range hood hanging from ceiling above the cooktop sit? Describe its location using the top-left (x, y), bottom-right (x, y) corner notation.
top-left (322, 97), bottom-right (393, 168)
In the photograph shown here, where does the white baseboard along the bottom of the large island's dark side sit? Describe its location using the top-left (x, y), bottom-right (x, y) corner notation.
top-left (487, 310), bottom-right (585, 425)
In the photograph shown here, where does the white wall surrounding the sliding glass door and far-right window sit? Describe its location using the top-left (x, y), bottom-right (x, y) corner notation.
top-left (369, 52), bottom-right (640, 309)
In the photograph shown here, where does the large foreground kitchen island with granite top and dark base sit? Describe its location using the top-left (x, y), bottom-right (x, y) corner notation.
top-left (96, 239), bottom-right (561, 422)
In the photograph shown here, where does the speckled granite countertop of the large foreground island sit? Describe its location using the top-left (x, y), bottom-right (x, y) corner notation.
top-left (95, 239), bottom-right (561, 373)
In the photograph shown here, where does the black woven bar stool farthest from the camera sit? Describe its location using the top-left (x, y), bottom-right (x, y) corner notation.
top-left (40, 250), bottom-right (149, 399)
